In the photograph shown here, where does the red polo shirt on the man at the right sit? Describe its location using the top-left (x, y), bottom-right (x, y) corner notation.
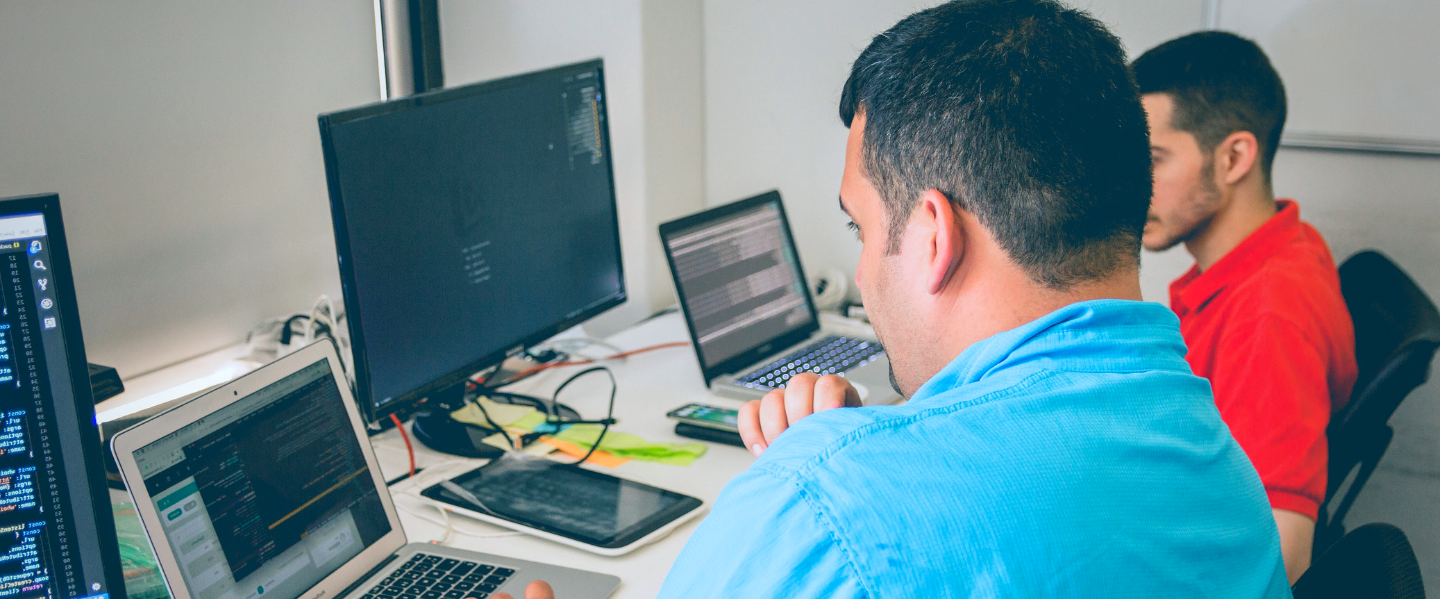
top-left (1171, 200), bottom-right (1356, 518)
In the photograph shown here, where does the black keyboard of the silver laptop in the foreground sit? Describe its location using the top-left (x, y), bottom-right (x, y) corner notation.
top-left (361, 553), bottom-right (516, 599)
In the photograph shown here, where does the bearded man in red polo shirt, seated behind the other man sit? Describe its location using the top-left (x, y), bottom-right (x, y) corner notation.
top-left (1130, 32), bottom-right (1356, 583)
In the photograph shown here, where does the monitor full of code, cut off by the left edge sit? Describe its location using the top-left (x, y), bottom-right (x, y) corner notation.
top-left (0, 194), bottom-right (125, 599)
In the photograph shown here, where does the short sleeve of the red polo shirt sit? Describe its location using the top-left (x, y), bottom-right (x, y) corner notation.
top-left (1210, 315), bottom-right (1331, 518)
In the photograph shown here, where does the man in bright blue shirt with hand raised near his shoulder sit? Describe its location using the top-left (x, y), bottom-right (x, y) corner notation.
top-left (501, 0), bottom-right (1290, 599)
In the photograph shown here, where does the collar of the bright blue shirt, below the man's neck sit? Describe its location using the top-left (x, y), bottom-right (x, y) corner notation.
top-left (910, 300), bottom-right (1189, 405)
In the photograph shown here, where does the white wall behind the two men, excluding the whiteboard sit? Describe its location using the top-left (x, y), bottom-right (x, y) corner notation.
top-left (704, 0), bottom-right (1440, 580)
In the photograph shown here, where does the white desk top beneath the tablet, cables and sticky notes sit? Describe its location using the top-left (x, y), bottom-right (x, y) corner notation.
top-left (96, 314), bottom-right (753, 599)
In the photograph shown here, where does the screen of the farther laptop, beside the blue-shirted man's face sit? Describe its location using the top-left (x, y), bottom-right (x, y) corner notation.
top-left (665, 192), bottom-right (816, 367)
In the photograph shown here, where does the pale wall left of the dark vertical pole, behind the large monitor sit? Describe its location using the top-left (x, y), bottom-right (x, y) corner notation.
top-left (0, 0), bottom-right (379, 377)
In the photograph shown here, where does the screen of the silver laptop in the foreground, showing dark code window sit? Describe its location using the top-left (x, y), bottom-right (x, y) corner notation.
top-left (134, 360), bottom-right (390, 599)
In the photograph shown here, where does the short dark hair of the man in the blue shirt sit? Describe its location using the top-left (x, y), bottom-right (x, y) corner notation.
top-left (840, 0), bottom-right (1151, 289)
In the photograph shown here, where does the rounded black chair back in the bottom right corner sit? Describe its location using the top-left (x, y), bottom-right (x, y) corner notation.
top-left (1292, 523), bottom-right (1426, 599)
